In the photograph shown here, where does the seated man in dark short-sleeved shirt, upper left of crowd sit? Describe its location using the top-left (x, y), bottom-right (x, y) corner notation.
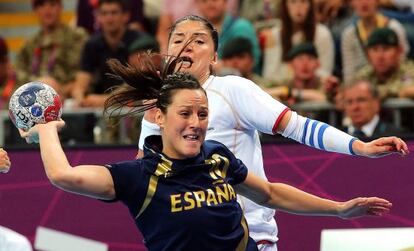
top-left (72, 0), bottom-right (150, 107)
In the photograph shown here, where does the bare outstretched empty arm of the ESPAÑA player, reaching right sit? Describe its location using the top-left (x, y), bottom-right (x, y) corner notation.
top-left (236, 173), bottom-right (392, 219)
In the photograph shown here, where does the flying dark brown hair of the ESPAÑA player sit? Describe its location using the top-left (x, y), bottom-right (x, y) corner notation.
top-left (104, 50), bottom-right (207, 117)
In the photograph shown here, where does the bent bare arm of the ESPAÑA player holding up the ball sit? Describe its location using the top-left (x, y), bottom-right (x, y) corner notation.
top-left (20, 120), bottom-right (115, 200)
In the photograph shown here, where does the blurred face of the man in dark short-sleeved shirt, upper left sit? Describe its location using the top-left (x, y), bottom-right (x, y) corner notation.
top-left (97, 3), bottom-right (129, 34)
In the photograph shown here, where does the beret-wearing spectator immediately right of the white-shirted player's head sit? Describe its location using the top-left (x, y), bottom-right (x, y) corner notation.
top-left (217, 37), bottom-right (272, 87)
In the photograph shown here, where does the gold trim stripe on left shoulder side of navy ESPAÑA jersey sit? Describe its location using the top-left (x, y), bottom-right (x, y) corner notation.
top-left (135, 155), bottom-right (172, 219)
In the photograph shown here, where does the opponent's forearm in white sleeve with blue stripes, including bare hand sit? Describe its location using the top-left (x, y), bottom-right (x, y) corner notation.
top-left (276, 111), bottom-right (409, 157)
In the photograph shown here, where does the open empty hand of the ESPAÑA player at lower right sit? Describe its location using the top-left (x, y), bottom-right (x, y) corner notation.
top-left (338, 197), bottom-right (392, 219)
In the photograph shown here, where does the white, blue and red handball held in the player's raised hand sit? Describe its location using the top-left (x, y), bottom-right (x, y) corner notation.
top-left (9, 82), bottom-right (62, 131)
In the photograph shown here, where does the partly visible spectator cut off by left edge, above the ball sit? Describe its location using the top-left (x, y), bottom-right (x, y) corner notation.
top-left (0, 37), bottom-right (16, 109)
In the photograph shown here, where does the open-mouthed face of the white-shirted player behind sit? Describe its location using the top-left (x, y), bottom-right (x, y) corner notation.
top-left (168, 20), bottom-right (217, 81)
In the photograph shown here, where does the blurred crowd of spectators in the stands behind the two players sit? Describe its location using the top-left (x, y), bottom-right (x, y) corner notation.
top-left (0, 0), bottom-right (414, 145)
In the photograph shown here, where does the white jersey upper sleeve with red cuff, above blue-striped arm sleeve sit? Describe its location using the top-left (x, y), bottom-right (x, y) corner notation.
top-left (226, 77), bottom-right (289, 134)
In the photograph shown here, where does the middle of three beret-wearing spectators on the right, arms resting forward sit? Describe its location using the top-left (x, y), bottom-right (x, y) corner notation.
top-left (265, 43), bottom-right (338, 104)
